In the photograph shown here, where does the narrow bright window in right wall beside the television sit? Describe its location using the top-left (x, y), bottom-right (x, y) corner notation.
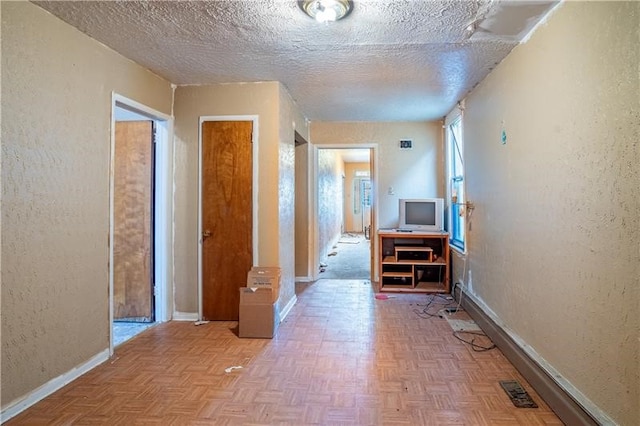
top-left (446, 115), bottom-right (466, 251)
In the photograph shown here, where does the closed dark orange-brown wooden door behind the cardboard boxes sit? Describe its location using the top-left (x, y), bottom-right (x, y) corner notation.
top-left (201, 121), bottom-right (253, 321)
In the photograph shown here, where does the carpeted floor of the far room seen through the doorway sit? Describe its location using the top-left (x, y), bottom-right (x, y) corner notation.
top-left (319, 233), bottom-right (371, 280)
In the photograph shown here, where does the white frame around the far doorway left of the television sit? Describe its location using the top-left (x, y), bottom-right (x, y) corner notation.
top-left (309, 142), bottom-right (379, 282)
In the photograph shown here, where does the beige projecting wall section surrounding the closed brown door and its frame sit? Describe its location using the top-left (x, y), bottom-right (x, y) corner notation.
top-left (174, 82), bottom-right (307, 313)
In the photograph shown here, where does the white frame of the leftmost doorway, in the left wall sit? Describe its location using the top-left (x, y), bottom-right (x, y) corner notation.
top-left (109, 92), bottom-right (174, 355)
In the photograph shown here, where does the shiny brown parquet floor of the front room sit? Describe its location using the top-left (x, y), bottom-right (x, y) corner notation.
top-left (7, 280), bottom-right (562, 426)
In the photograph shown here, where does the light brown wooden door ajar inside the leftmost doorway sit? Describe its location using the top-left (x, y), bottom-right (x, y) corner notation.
top-left (113, 121), bottom-right (154, 322)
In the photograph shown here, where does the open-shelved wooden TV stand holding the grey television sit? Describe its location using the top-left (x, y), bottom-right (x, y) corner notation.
top-left (378, 229), bottom-right (451, 293)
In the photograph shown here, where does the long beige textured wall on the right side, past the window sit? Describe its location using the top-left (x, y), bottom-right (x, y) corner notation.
top-left (456, 2), bottom-right (640, 425)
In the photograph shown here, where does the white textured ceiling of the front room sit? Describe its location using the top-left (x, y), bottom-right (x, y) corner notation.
top-left (34, 0), bottom-right (556, 121)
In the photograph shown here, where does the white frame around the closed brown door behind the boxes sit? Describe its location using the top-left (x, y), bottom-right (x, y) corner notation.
top-left (197, 115), bottom-right (260, 323)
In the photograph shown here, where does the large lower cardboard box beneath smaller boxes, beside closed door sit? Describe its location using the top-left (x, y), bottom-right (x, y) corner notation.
top-left (238, 287), bottom-right (277, 339)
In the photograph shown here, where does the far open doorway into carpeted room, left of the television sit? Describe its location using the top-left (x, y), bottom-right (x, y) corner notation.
top-left (317, 147), bottom-right (373, 279)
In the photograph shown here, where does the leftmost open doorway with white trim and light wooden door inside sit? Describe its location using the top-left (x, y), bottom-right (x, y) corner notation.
top-left (109, 94), bottom-right (172, 354)
